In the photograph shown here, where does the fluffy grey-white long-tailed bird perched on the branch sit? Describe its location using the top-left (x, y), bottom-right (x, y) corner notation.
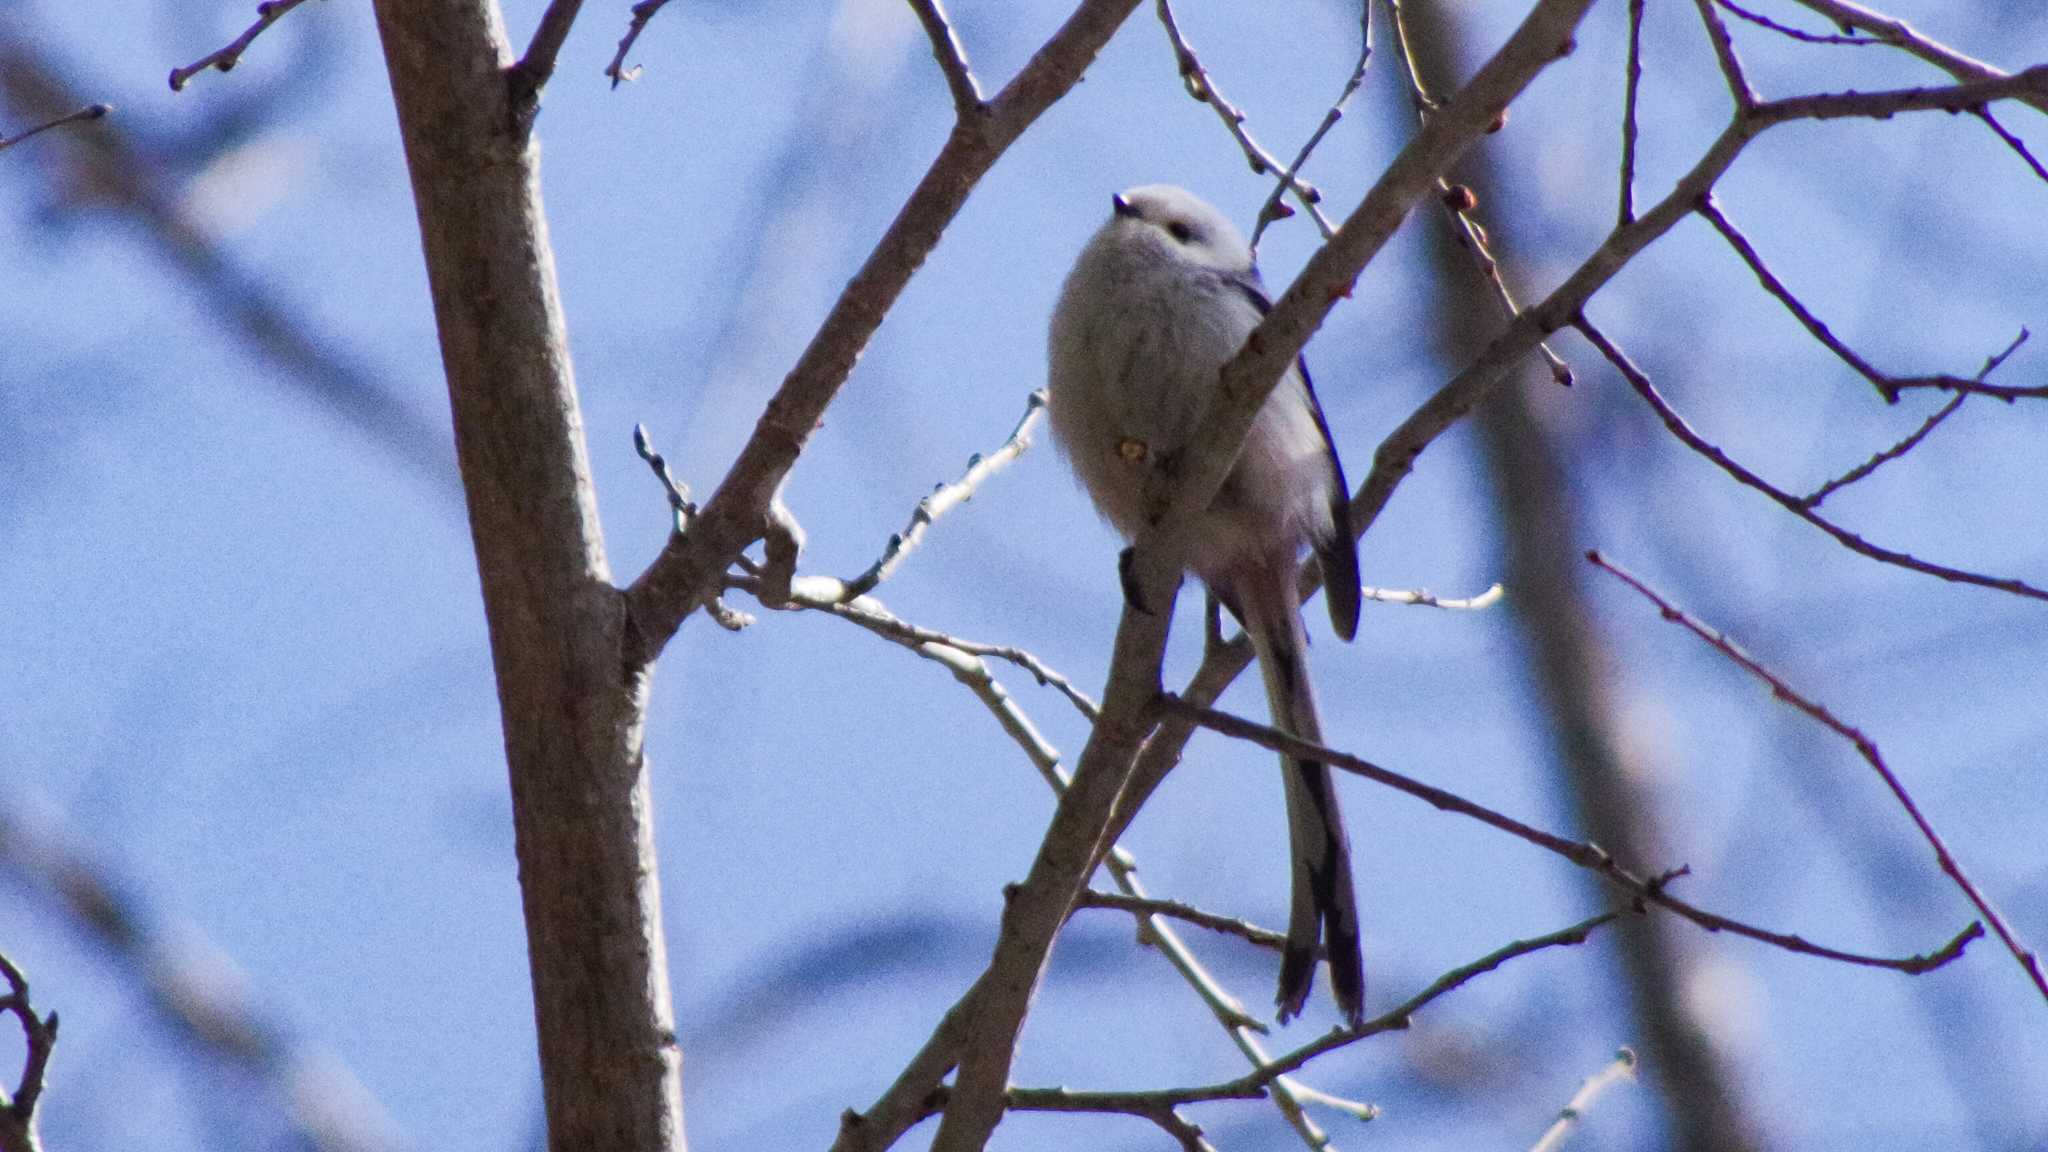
top-left (1051, 184), bottom-right (1366, 1023)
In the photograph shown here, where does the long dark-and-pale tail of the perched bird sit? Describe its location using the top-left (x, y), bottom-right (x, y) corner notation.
top-left (1233, 572), bottom-right (1366, 1025)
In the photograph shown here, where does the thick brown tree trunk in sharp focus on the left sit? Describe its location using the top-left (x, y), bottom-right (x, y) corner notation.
top-left (377, 0), bottom-right (682, 1152)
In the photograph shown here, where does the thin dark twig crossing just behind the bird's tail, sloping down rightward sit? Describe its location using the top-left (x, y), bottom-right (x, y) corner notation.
top-left (1159, 693), bottom-right (1985, 976)
